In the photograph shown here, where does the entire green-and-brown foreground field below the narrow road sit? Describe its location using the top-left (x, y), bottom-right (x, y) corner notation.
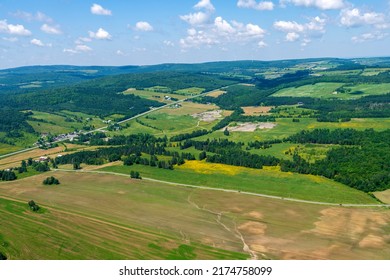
top-left (0, 171), bottom-right (390, 259)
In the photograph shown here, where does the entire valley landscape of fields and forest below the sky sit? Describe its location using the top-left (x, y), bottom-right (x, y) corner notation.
top-left (0, 59), bottom-right (390, 260)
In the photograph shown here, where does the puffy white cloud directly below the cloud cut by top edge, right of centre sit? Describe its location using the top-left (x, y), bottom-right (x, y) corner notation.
top-left (273, 16), bottom-right (326, 42)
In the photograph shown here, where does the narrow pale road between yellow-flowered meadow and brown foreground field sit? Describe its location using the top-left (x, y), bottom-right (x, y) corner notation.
top-left (53, 169), bottom-right (390, 208)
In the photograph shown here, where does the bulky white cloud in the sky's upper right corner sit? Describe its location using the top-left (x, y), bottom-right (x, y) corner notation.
top-left (340, 8), bottom-right (386, 28)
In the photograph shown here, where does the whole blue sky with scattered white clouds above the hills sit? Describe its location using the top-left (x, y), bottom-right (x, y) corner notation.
top-left (0, 0), bottom-right (390, 69)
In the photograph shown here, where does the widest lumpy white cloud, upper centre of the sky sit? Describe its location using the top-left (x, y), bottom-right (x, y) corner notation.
top-left (180, 17), bottom-right (266, 48)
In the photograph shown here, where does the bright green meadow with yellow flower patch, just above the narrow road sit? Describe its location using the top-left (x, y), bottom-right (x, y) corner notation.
top-left (98, 161), bottom-right (377, 204)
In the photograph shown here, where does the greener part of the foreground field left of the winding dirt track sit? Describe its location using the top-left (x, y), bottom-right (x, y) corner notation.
top-left (0, 172), bottom-right (247, 259)
